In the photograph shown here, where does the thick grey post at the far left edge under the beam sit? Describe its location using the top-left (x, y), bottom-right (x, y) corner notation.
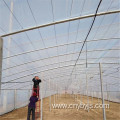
top-left (0, 37), bottom-right (3, 90)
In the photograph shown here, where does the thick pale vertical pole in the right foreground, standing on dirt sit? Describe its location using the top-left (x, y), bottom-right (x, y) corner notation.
top-left (99, 63), bottom-right (106, 120)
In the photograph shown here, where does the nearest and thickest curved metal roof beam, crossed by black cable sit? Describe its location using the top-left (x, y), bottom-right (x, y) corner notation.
top-left (1, 10), bottom-right (120, 37)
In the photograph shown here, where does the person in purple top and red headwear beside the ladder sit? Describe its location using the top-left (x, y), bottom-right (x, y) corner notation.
top-left (27, 92), bottom-right (38, 120)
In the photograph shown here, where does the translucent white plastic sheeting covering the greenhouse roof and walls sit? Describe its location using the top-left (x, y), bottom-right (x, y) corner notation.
top-left (0, 0), bottom-right (120, 114)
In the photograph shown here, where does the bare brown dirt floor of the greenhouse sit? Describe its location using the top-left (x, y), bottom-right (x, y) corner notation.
top-left (0, 94), bottom-right (120, 120)
